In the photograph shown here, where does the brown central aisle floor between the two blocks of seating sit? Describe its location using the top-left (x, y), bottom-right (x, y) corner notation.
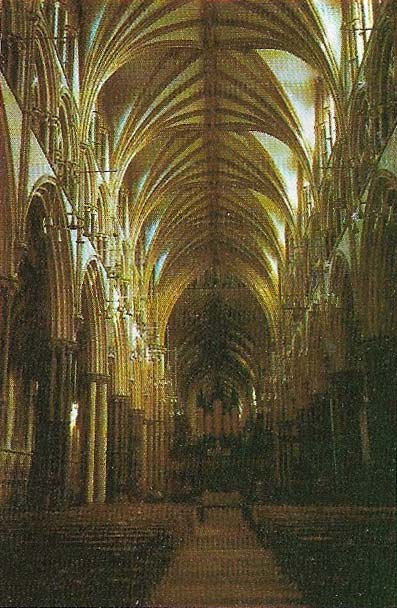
top-left (148, 508), bottom-right (303, 608)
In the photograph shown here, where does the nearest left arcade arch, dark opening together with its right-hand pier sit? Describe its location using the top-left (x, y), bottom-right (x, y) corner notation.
top-left (6, 192), bottom-right (73, 509)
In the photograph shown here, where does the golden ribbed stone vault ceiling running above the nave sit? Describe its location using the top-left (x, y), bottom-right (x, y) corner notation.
top-left (80, 0), bottom-right (339, 406)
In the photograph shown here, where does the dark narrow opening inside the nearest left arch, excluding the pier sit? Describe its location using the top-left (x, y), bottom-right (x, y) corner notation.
top-left (5, 202), bottom-right (50, 505)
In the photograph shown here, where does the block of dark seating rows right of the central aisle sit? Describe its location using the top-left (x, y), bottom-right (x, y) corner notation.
top-left (251, 505), bottom-right (395, 608)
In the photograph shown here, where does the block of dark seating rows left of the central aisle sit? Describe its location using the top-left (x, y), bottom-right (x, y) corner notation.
top-left (0, 504), bottom-right (194, 606)
